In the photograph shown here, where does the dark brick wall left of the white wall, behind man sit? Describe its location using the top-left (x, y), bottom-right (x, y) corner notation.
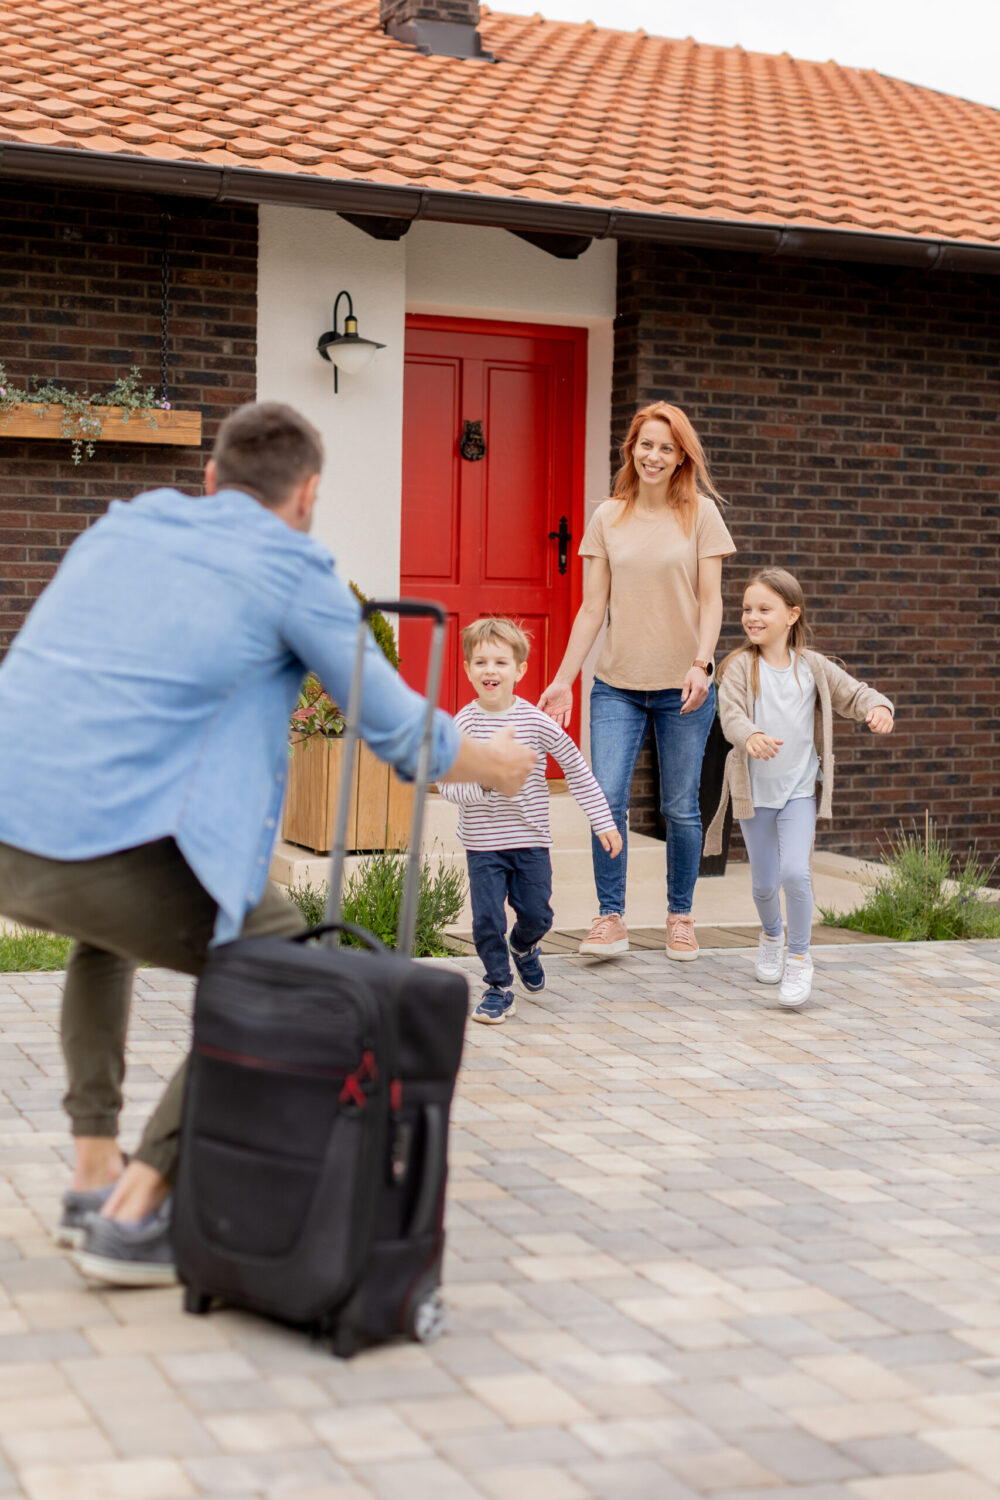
top-left (0, 183), bottom-right (256, 653)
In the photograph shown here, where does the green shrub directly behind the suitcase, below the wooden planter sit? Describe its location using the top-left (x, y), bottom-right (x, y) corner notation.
top-left (288, 849), bottom-right (465, 959)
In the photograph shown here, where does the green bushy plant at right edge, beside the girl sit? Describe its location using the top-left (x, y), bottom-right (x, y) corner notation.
top-left (820, 818), bottom-right (1000, 942)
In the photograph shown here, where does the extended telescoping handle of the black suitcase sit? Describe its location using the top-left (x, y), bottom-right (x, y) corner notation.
top-left (324, 599), bottom-right (447, 954)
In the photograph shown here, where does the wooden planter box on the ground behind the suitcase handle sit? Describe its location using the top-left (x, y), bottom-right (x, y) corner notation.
top-left (282, 735), bottom-right (414, 854)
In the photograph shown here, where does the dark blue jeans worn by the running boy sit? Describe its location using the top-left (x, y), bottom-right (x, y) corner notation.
top-left (465, 848), bottom-right (552, 990)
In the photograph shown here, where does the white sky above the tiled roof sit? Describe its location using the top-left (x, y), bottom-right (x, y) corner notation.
top-left (487, 0), bottom-right (1000, 110)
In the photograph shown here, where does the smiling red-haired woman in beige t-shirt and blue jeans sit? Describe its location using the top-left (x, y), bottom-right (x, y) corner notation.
top-left (538, 402), bottom-right (736, 960)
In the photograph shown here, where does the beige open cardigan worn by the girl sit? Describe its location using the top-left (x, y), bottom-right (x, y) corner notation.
top-left (705, 651), bottom-right (894, 854)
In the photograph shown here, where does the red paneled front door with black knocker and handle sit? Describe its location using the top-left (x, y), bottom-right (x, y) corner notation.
top-left (400, 315), bottom-right (586, 762)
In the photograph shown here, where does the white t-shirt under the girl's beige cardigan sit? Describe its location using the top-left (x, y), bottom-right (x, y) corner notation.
top-left (750, 657), bottom-right (820, 807)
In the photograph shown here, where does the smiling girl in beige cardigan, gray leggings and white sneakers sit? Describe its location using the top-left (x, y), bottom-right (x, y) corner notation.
top-left (705, 567), bottom-right (894, 1010)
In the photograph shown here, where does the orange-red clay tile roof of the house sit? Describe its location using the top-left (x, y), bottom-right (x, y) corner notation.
top-left (0, 0), bottom-right (1000, 243)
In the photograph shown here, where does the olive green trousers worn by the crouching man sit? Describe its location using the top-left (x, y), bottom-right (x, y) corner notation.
top-left (0, 839), bottom-right (304, 1181)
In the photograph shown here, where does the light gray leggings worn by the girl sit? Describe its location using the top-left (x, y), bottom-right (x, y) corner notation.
top-left (739, 797), bottom-right (816, 954)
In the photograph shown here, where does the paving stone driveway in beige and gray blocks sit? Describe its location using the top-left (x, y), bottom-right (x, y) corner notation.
top-left (0, 944), bottom-right (1000, 1500)
